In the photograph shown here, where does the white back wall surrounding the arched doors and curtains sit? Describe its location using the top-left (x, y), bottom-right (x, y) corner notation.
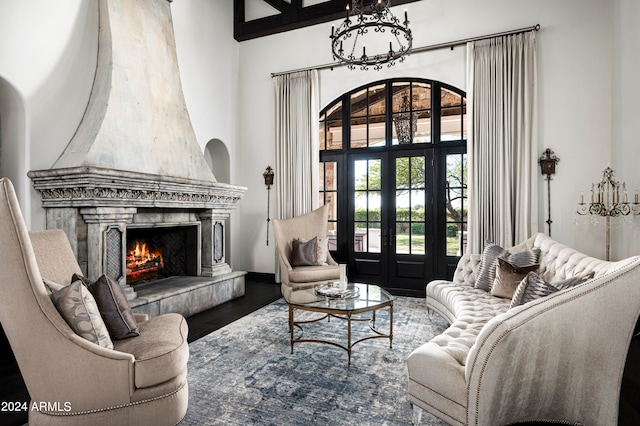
top-left (234, 0), bottom-right (620, 272)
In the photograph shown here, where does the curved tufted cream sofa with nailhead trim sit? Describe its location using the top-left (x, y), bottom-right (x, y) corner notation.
top-left (407, 234), bottom-right (640, 426)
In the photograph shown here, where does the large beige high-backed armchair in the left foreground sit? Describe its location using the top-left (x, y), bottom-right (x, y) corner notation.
top-left (0, 178), bottom-right (189, 425)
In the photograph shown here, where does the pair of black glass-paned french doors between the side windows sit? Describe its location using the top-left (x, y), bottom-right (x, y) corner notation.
top-left (347, 149), bottom-right (435, 293)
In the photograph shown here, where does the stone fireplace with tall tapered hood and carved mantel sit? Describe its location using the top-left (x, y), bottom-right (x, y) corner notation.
top-left (29, 0), bottom-right (246, 316)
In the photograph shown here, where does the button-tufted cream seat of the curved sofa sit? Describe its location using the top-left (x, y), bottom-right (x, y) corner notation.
top-left (427, 281), bottom-right (511, 367)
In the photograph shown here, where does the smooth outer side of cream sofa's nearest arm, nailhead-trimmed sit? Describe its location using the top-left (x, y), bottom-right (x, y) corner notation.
top-left (465, 261), bottom-right (640, 425)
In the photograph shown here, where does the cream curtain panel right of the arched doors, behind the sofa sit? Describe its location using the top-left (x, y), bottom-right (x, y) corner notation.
top-left (467, 31), bottom-right (538, 253)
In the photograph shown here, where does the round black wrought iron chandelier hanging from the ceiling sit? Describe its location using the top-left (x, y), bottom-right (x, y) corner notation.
top-left (331, 0), bottom-right (413, 70)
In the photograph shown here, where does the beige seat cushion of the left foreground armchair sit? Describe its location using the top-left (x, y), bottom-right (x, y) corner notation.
top-left (114, 313), bottom-right (189, 388)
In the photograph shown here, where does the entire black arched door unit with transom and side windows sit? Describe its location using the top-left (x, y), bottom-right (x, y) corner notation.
top-left (319, 79), bottom-right (467, 296)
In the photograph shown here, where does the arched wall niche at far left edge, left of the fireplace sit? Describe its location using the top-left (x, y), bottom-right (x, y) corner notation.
top-left (0, 76), bottom-right (31, 226)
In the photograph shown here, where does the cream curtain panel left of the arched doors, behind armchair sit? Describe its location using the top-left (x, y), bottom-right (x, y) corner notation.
top-left (273, 70), bottom-right (320, 282)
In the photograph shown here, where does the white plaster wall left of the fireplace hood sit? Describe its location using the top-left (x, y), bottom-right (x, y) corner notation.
top-left (0, 0), bottom-right (98, 229)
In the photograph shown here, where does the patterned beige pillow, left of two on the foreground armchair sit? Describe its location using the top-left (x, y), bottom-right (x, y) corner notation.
top-left (51, 281), bottom-right (113, 349)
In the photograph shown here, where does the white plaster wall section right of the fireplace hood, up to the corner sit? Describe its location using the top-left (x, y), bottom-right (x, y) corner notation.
top-left (171, 0), bottom-right (241, 270)
